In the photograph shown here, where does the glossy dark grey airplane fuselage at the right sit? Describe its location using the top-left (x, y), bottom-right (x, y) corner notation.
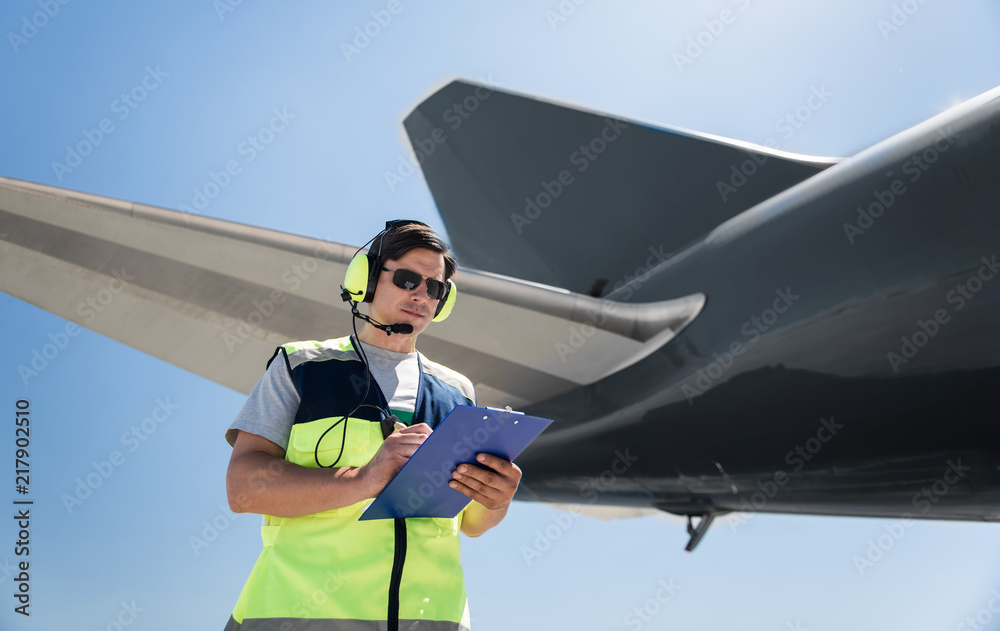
top-left (520, 87), bottom-right (1000, 520)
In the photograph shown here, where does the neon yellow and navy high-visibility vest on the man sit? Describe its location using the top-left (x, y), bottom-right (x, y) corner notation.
top-left (226, 337), bottom-right (475, 631)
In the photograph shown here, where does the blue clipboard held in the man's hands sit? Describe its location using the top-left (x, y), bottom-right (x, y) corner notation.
top-left (358, 405), bottom-right (552, 520)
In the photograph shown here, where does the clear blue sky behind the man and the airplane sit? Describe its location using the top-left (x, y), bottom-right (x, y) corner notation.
top-left (0, 0), bottom-right (1000, 631)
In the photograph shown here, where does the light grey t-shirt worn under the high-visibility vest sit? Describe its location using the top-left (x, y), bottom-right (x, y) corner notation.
top-left (226, 342), bottom-right (420, 449)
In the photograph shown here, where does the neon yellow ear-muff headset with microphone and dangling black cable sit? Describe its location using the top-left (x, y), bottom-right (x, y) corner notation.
top-left (313, 219), bottom-right (458, 469)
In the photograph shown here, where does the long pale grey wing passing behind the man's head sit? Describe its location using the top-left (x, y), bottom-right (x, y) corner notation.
top-left (0, 178), bottom-right (705, 406)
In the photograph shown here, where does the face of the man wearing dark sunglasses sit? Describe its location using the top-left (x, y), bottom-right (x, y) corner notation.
top-left (369, 248), bottom-right (444, 336)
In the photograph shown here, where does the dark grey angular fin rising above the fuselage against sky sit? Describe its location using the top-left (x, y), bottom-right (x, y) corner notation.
top-left (403, 81), bottom-right (836, 296)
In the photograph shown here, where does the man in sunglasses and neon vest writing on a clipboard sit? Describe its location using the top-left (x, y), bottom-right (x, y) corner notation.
top-left (226, 221), bottom-right (521, 631)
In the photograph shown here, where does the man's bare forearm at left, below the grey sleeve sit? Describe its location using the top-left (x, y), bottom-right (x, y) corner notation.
top-left (226, 452), bottom-right (374, 517)
